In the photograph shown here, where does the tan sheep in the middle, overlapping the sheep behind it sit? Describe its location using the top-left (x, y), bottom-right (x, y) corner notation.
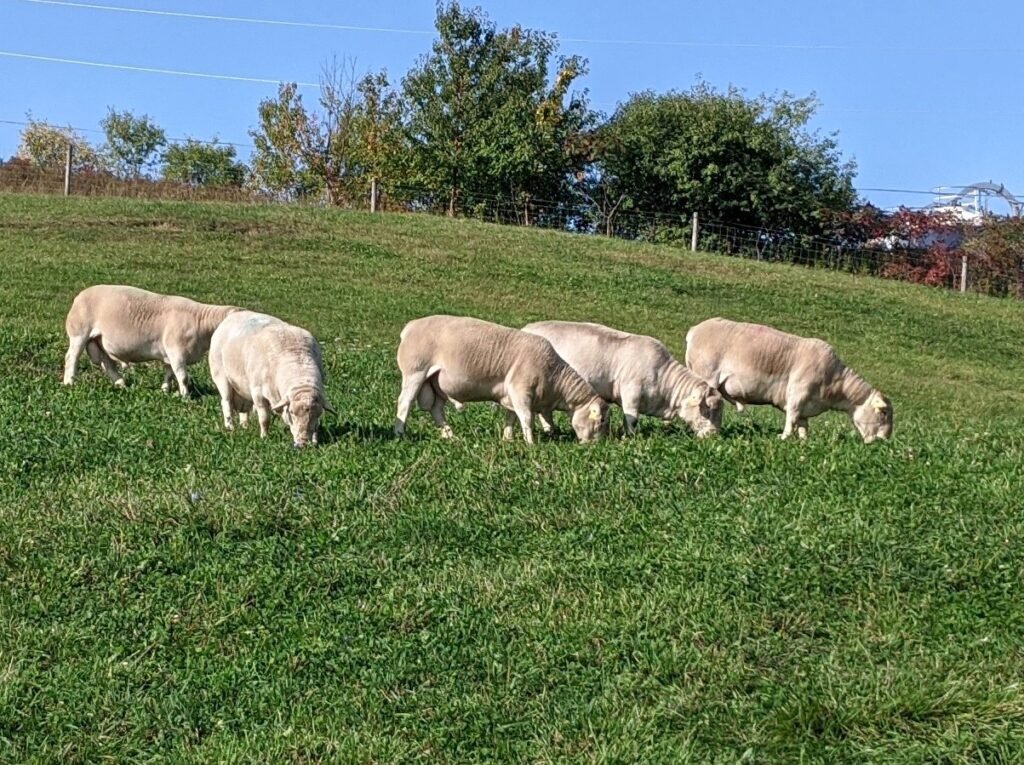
top-left (394, 315), bottom-right (608, 443)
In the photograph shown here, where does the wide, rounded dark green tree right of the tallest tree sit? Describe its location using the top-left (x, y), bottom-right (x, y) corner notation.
top-left (596, 82), bottom-right (856, 235)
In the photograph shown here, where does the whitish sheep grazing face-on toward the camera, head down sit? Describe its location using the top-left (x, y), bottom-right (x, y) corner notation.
top-left (210, 310), bottom-right (334, 448)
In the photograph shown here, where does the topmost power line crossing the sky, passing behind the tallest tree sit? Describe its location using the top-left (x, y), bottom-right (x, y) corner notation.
top-left (18, 0), bottom-right (1024, 54)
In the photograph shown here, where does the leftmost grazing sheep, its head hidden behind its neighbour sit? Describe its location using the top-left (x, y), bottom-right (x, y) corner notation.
top-left (63, 285), bottom-right (238, 396)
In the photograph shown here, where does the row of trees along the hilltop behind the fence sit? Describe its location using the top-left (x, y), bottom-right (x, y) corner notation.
top-left (4, 2), bottom-right (858, 238)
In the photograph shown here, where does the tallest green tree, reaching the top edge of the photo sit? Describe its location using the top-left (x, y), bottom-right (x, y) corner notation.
top-left (402, 2), bottom-right (591, 216)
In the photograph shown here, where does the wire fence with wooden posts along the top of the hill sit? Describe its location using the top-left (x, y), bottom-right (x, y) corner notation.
top-left (6, 157), bottom-right (1024, 299)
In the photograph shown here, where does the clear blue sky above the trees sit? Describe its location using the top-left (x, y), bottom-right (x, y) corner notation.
top-left (0, 0), bottom-right (1024, 211)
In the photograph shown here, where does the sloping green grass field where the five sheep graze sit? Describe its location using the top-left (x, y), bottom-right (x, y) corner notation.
top-left (0, 196), bottom-right (1024, 763)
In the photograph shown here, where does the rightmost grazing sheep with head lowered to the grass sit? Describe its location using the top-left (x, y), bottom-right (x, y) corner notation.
top-left (686, 318), bottom-right (893, 443)
